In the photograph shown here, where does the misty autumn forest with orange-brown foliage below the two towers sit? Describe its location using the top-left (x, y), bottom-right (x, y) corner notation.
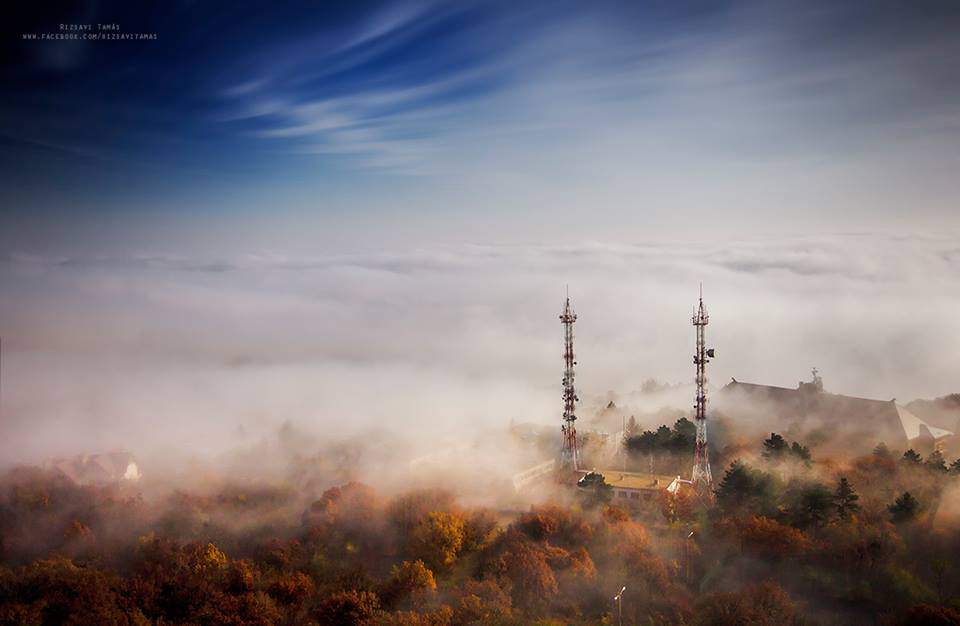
top-left (0, 420), bottom-right (960, 626)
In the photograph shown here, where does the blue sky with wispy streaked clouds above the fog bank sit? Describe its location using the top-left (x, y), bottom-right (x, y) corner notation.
top-left (0, 2), bottom-right (960, 250)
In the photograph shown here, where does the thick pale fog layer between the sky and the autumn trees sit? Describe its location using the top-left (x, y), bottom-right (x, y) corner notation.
top-left (0, 235), bottom-right (960, 476)
